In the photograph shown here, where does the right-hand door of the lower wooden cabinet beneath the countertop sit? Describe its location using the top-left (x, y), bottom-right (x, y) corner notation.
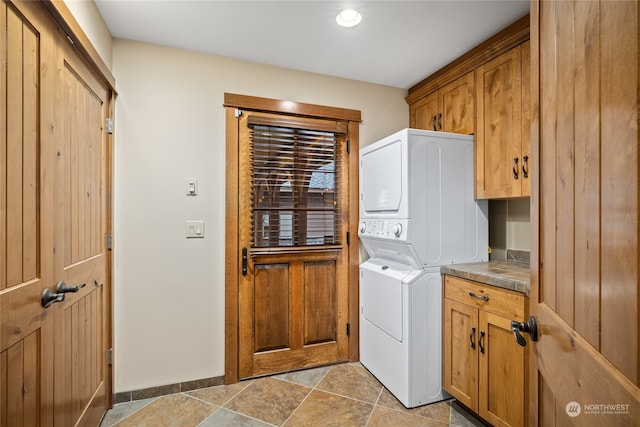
top-left (478, 310), bottom-right (525, 427)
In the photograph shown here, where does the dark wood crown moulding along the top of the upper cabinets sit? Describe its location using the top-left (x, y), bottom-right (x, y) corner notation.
top-left (405, 15), bottom-right (529, 104)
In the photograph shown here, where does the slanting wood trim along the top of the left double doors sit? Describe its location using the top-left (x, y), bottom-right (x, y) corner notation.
top-left (40, 0), bottom-right (116, 90)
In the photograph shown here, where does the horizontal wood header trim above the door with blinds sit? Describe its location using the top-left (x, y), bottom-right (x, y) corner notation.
top-left (224, 93), bottom-right (362, 122)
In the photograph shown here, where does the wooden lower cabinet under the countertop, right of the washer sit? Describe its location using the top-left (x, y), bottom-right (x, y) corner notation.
top-left (443, 275), bottom-right (527, 426)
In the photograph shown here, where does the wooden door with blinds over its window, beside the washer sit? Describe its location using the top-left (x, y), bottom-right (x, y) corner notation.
top-left (238, 112), bottom-right (349, 378)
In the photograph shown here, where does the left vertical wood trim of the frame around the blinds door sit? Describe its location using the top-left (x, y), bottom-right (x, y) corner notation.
top-left (224, 108), bottom-right (241, 384)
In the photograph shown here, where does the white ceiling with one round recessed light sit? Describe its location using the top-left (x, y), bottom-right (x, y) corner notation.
top-left (95, 0), bottom-right (529, 88)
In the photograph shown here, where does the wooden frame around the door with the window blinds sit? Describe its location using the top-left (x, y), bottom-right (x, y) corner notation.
top-left (224, 93), bottom-right (361, 384)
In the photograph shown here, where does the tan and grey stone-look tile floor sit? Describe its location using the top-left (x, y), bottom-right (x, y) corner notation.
top-left (101, 363), bottom-right (482, 427)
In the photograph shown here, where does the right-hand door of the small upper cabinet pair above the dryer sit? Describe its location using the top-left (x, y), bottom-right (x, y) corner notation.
top-left (437, 71), bottom-right (476, 134)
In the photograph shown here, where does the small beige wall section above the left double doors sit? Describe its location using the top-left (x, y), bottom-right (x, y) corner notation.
top-left (64, 0), bottom-right (113, 69)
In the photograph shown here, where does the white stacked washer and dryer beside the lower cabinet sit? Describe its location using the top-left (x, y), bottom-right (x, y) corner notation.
top-left (358, 129), bottom-right (488, 408)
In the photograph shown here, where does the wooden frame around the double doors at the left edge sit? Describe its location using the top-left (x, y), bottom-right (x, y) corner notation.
top-left (38, 0), bottom-right (117, 408)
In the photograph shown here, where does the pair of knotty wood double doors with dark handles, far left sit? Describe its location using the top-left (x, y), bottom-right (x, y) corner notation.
top-left (0, 1), bottom-right (111, 426)
